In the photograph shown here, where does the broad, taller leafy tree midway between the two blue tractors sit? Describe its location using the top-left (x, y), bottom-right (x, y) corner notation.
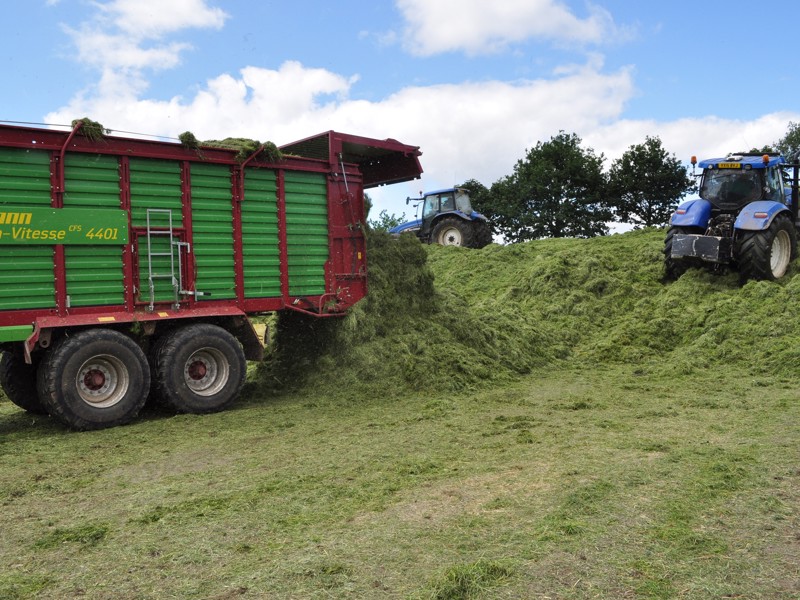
top-left (488, 131), bottom-right (612, 242)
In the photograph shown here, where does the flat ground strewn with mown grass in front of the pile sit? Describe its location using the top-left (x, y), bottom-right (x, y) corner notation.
top-left (0, 367), bottom-right (800, 599)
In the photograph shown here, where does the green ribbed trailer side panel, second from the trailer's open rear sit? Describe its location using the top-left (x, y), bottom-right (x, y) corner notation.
top-left (242, 169), bottom-right (281, 298)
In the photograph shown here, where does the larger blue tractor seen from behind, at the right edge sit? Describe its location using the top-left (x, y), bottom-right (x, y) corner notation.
top-left (664, 152), bottom-right (800, 284)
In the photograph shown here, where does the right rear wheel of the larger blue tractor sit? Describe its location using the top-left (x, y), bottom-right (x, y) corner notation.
top-left (736, 215), bottom-right (797, 284)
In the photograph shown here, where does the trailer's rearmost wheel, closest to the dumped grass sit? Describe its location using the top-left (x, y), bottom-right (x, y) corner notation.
top-left (151, 323), bottom-right (247, 414)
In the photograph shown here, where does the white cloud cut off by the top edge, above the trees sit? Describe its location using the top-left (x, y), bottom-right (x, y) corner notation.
top-left (397, 0), bottom-right (628, 56)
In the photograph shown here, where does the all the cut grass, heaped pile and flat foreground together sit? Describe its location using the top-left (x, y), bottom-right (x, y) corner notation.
top-left (0, 232), bottom-right (800, 599)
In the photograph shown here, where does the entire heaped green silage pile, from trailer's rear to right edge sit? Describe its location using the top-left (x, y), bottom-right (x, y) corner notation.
top-left (263, 230), bottom-right (800, 394)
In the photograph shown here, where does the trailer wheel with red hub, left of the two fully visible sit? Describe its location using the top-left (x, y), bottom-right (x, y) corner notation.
top-left (37, 329), bottom-right (150, 430)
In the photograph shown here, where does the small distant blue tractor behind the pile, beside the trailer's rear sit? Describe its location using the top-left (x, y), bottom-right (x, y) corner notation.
top-left (389, 188), bottom-right (492, 248)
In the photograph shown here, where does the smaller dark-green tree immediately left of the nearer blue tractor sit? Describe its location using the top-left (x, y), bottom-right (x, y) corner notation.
top-left (608, 136), bottom-right (694, 227)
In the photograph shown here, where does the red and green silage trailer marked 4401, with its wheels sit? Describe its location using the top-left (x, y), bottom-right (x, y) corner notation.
top-left (0, 121), bottom-right (422, 429)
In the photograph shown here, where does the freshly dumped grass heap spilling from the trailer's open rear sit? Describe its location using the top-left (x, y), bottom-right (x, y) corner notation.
top-left (261, 233), bottom-right (555, 395)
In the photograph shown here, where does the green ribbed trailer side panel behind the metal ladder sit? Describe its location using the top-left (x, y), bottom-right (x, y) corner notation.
top-left (129, 158), bottom-right (183, 302)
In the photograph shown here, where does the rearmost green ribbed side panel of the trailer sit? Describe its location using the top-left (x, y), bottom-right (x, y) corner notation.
top-left (284, 171), bottom-right (329, 296)
